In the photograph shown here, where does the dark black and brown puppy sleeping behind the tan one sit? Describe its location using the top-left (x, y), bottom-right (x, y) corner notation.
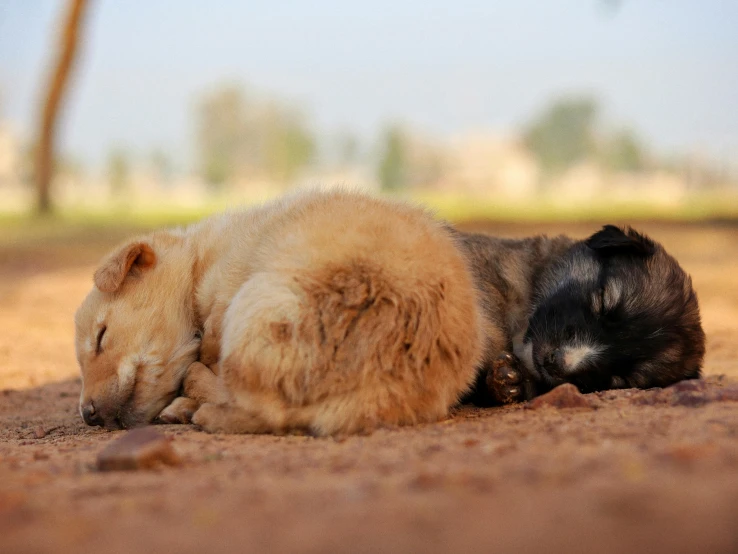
top-left (460, 225), bottom-right (705, 405)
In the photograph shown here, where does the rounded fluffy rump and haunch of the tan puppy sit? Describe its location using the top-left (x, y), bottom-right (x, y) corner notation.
top-left (211, 188), bottom-right (482, 434)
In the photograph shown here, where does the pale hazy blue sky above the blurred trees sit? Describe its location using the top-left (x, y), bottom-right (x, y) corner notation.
top-left (0, 0), bottom-right (738, 165)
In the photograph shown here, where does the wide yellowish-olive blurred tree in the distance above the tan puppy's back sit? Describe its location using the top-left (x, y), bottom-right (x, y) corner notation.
top-left (197, 86), bottom-right (315, 187)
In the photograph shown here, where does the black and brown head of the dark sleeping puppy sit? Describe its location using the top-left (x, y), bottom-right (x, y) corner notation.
top-left (526, 225), bottom-right (705, 390)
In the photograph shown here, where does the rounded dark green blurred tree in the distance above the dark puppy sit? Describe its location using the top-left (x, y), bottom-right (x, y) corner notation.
top-left (523, 98), bottom-right (598, 174)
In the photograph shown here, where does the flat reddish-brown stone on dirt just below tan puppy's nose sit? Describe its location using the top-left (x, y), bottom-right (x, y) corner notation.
top-left (97, 427), bottom-right (181, 471)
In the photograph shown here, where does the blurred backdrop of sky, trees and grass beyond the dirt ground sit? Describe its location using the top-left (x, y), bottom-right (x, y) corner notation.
top-left (0, 0), bottom-right (738, 220)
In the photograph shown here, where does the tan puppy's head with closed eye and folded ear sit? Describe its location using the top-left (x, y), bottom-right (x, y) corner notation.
top-left (75, 233), bottom-right (200, 429)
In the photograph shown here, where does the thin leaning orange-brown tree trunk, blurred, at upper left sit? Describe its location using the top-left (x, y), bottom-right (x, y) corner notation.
top-left (35, 0), bottom-right (88, 214)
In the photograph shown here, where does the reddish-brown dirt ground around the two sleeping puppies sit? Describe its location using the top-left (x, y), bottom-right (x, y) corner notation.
top-left (0, 218), bottom-right (738, 554)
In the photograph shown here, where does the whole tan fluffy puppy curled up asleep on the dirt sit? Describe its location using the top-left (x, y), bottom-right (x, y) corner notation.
top-left (76, 191), bottom-right (483, 435)
